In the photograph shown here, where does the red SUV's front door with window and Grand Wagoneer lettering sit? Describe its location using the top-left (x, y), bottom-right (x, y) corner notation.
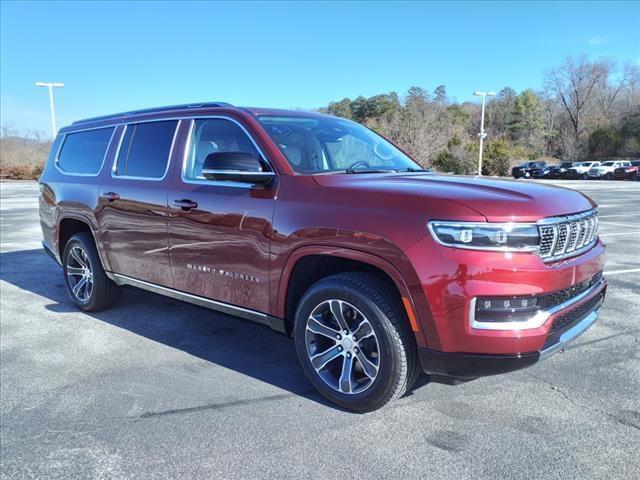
top-left (169, 117), bottom-right (275, 312)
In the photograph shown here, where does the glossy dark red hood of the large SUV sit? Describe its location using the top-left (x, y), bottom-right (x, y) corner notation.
top-left (314, 173), bottom-right (596, 222)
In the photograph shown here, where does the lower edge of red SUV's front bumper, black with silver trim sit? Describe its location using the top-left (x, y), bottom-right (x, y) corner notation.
top-left (418, 283), bottom-right (606, 380)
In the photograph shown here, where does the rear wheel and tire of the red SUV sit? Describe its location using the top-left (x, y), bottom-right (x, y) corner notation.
top-left (62, 232), bottom-right (120, 312)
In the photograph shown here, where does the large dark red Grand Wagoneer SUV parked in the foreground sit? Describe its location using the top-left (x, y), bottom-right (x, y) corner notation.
top-left (40, 103), bottom-right (606, 412)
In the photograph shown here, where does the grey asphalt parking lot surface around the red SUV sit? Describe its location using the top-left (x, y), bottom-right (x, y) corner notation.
top-left (0, 180), bottom-right (640, 479)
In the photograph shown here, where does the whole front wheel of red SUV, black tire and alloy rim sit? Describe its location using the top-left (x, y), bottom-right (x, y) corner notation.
top-left (294, 272), bottom-right (420, 413)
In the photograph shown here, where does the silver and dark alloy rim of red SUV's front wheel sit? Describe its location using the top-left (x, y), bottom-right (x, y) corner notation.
top-left (305, 299), bottom-right (380, 395)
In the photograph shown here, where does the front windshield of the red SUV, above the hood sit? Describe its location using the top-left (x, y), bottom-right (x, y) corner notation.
top-left (258, 115), bottom-right (422, 173)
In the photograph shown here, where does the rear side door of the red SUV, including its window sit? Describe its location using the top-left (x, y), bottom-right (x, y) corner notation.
top-left (96, 120), bottom-right (179, 287)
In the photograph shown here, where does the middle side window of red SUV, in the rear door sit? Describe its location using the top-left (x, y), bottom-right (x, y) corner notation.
top-left (115, 120), bottom-right (178, 179)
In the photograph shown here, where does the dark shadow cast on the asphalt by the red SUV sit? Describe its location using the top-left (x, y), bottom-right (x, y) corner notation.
top-left (0, 249), bottom-right (428, 410)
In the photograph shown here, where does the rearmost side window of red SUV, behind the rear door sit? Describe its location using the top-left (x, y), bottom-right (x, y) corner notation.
top-left (57, 127), bottom-right (114, 175)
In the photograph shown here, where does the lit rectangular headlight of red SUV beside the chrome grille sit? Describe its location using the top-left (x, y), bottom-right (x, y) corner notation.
top-left (429, 221), bottom-right (540, 252)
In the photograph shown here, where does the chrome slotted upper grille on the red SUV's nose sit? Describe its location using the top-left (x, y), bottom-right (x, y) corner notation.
top-left (538, 210), bottom-right (598, 262)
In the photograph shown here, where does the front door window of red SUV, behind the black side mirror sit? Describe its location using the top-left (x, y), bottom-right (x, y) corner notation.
top-left (185, 118), bottom-right (260, 180)
